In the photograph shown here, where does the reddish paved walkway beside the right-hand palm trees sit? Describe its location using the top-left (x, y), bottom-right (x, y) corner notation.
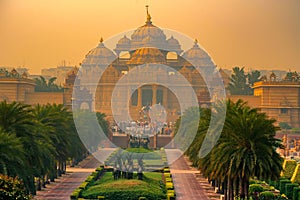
top-left (166, 149), bottom-right (220, 200)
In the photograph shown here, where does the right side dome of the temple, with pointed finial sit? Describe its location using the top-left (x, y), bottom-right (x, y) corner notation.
top-left (182, 39), bottom-right (215, 67)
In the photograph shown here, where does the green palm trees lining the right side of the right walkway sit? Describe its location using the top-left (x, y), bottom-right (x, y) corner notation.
top-left (180, 100), bottom-right (283, 200)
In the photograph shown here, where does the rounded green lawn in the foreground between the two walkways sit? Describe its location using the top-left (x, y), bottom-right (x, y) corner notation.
top-left (81, 172), bottom-right (166, 200)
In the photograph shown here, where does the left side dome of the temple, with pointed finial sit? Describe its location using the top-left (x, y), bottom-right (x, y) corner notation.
top-left (82, 38), bottom-right (116, 67)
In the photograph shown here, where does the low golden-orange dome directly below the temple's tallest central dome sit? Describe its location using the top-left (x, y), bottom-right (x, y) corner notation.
top-left (128, 48), bottom-right (166, 65)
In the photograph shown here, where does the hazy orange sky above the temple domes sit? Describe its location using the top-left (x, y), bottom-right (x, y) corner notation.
top-left (0, 0), bottom-right (300, 74)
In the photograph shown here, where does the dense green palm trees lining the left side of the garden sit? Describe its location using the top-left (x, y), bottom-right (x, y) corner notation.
top-left (0, 101), bottom-right (92, 194)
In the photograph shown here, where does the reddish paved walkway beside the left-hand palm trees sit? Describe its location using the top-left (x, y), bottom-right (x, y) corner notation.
top-left (34, 148), bottom-right (115, 200)
